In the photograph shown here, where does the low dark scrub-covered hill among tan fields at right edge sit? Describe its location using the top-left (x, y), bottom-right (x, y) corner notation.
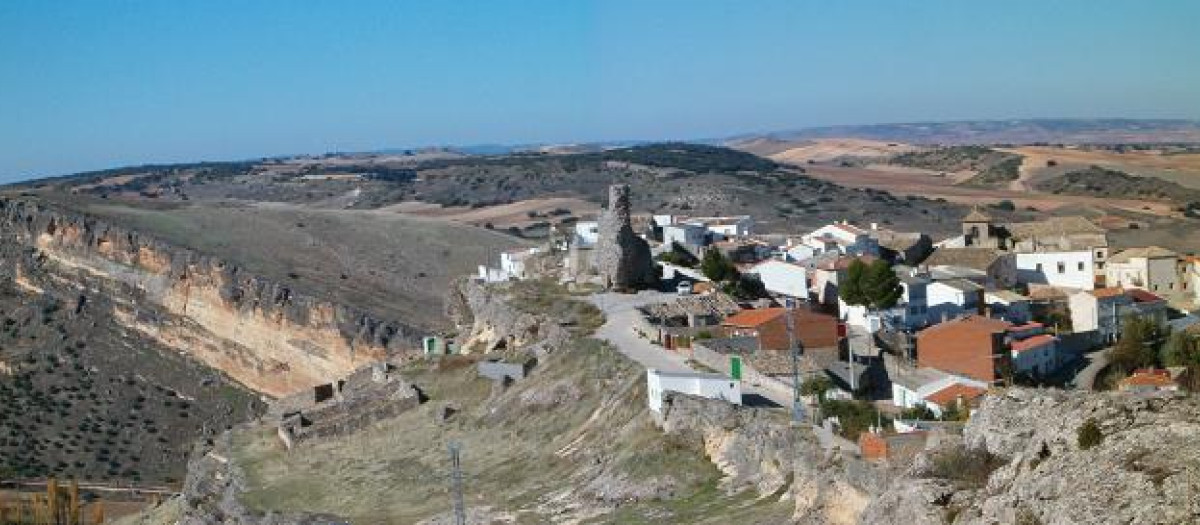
top-left (1034, 165), bottom-right (1200, 203)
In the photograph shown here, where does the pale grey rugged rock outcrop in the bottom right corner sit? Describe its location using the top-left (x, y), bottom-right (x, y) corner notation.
top-left (863, 388), bottom-right (1200, 524)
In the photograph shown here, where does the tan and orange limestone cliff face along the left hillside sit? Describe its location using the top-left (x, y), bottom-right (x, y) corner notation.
top-left (0, 199), bottom-right (415, 397)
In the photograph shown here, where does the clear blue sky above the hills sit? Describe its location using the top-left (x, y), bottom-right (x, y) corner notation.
top-left (0, 0), bottom-right (1200, 181)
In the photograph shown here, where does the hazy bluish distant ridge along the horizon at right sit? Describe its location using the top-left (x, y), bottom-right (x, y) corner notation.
top-left (753, 119), bottom-right (1200, 145)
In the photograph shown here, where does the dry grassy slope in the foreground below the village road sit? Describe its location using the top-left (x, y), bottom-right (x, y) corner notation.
top-left (226, 340), bottom-right (718, 524)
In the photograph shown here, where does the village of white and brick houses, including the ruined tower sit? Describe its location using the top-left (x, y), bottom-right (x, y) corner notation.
top-left (475, 185), bottom-right (1200, 459)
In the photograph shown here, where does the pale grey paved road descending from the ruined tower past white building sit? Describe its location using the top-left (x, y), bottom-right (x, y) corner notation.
top-left (590, 291), bottom-right (792, 408)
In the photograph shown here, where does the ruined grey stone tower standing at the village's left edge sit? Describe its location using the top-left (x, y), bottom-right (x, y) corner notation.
top-left (595, 185), bottom-right (658, 290)
